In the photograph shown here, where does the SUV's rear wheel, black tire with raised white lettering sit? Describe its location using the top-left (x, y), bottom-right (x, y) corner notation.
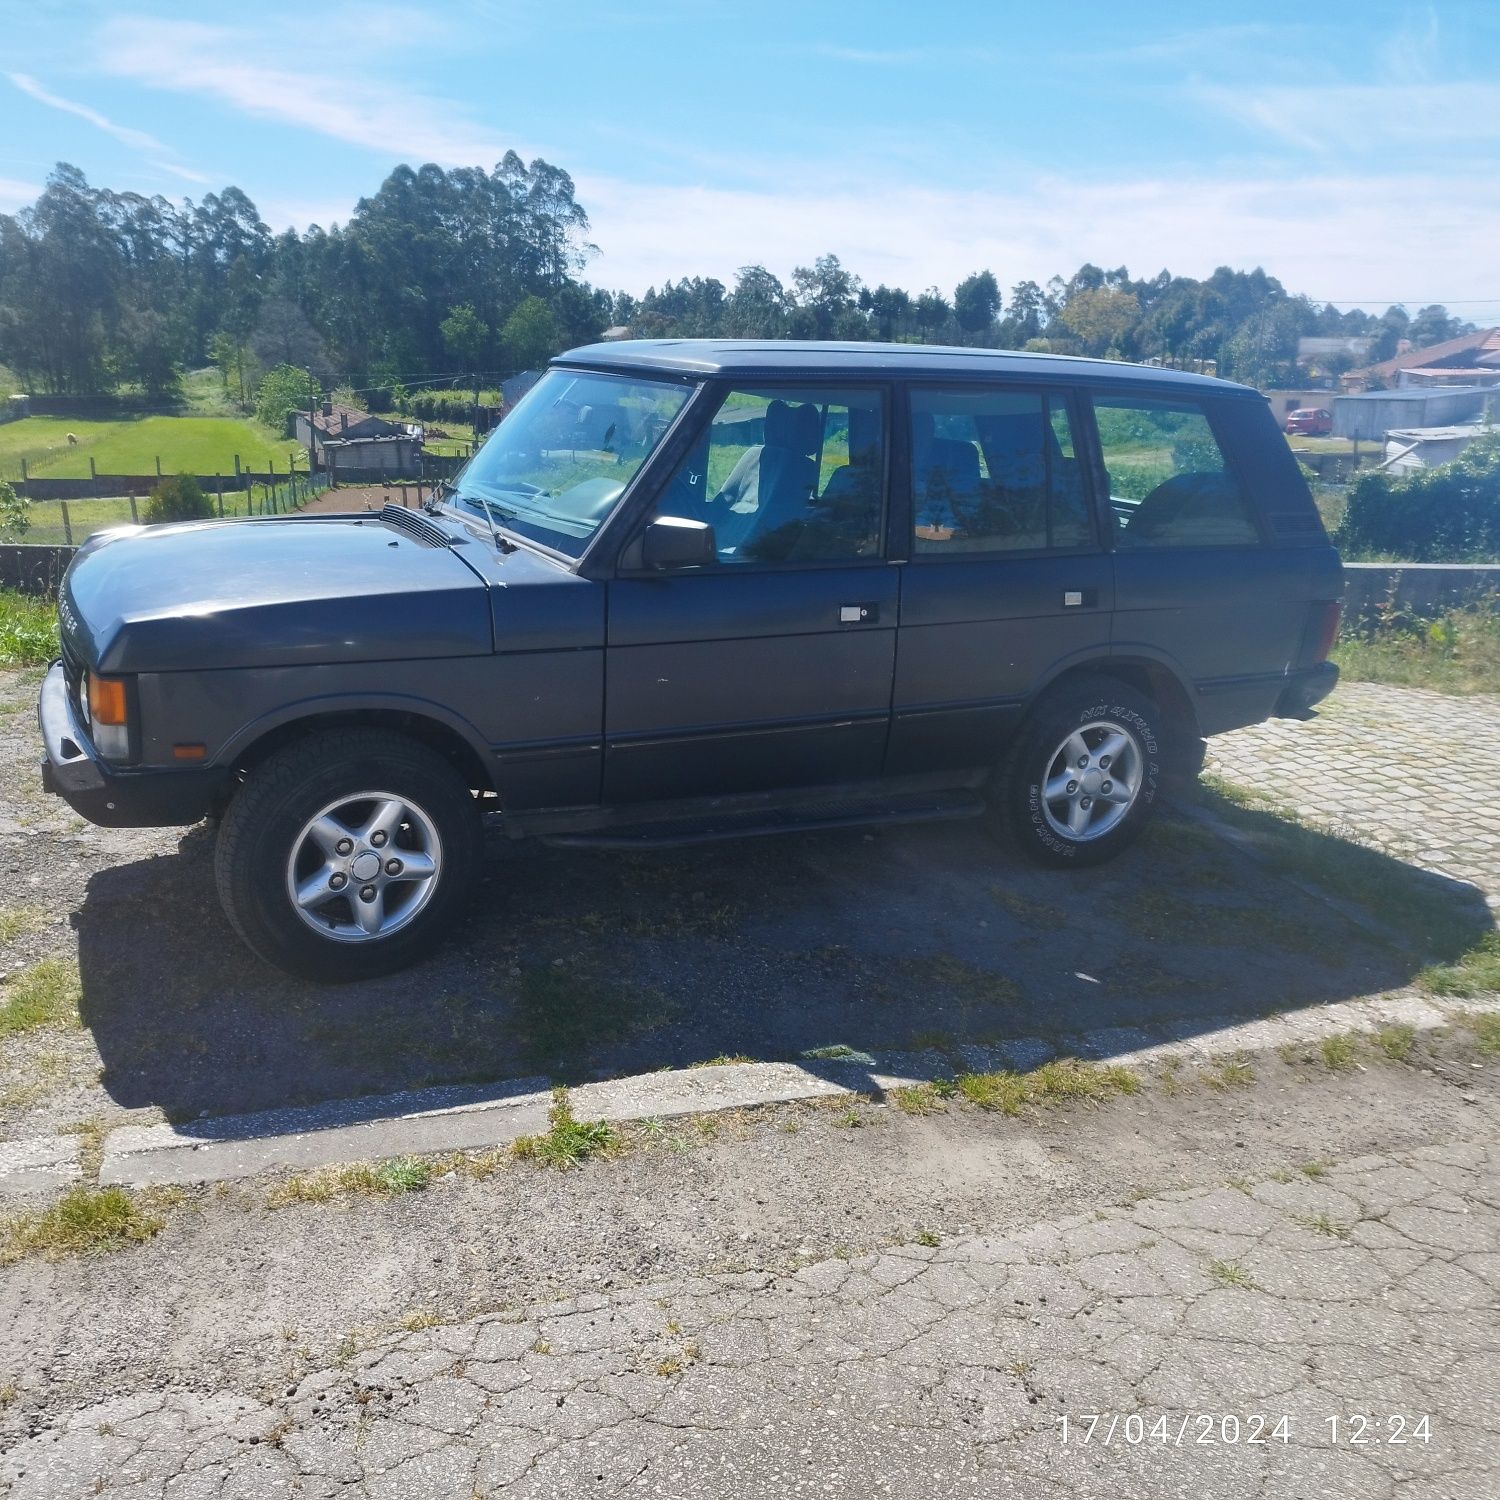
top-left (998, 677), bottom-right (1172, 869)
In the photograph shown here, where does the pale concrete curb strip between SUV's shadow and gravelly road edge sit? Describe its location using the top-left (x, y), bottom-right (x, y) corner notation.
top-left (0, 992), bottom-right (1500, 1194)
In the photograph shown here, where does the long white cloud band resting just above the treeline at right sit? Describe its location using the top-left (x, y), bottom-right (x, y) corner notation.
top-left (578, 176), bottom-right (1500, 317)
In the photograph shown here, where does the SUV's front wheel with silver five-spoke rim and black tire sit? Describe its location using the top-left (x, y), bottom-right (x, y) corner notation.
top-left (215, 731), bottom-right (482, 984)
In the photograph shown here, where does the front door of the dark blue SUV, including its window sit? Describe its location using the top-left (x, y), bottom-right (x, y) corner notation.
top-left (605, 384), bottom-right (899, 804)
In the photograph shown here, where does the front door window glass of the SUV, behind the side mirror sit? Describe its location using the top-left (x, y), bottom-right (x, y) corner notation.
top-left (657, 386), bottom-right (885, 567)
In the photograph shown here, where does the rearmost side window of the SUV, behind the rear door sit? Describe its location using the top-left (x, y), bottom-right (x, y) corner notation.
top-left (1094, 396), bottom-right (1260, 548)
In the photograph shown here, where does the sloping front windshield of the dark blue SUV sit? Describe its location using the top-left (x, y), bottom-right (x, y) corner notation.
top-left (438, 369), bottom-right (690, 558)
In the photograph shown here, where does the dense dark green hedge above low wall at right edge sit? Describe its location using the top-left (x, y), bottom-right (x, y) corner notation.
top-left (1337, 431), bottom-right (1500, 563)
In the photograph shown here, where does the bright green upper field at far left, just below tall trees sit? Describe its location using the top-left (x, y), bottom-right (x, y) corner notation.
top-left (0, 417), bottom-right (302, 479)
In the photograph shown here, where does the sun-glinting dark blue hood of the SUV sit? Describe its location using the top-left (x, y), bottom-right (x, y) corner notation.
top-left (59, 515), bottom-right (494, 672)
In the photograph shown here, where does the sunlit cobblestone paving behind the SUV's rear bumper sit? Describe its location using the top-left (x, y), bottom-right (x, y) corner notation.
top-left (1208, 683), bottom-right (1500, 906)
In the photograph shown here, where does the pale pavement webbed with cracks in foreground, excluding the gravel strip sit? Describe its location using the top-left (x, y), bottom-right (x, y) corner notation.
top-left (0, 1134), bottom-right (1500, 1500)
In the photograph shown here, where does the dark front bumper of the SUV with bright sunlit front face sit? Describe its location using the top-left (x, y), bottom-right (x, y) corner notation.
top-left (36, 662), bottom-right (233, 828)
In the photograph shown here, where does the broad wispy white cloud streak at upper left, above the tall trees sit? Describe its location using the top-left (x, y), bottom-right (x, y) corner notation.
top-left (96, 18), bottom-right (510, 167)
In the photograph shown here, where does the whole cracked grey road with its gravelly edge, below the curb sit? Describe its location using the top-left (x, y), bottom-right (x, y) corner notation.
top-left (0, 1043), bottom-right (1500, 1500)
